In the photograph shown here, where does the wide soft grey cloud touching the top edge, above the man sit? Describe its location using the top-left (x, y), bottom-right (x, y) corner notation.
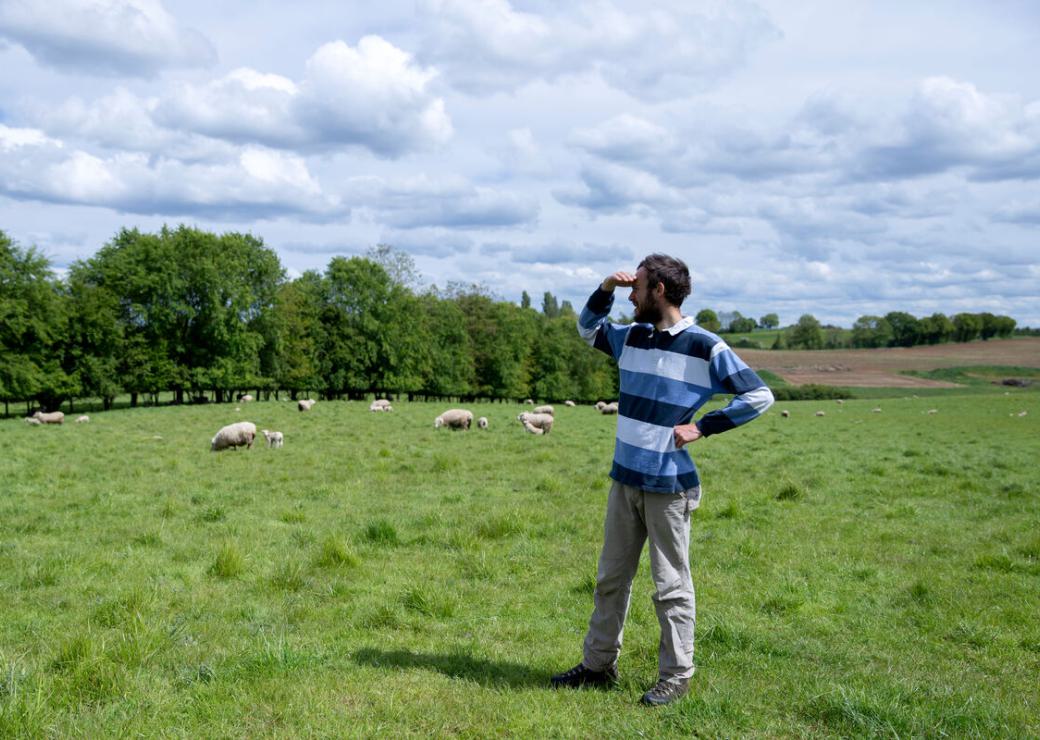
top-left (420, 0), bottom-right (779, 100)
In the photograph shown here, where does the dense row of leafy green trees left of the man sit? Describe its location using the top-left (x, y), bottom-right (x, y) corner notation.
top-left (0, 226), bottom-right (618, 414)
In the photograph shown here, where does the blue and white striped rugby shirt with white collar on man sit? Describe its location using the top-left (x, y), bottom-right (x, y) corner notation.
top-left (578, 288), bottom-right (773, 493)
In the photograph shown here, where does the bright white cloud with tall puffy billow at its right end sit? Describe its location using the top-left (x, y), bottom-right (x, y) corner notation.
top-left (46, 36), bottom-right (452, 157)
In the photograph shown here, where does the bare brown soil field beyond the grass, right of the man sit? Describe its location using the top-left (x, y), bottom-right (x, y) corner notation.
top-left (736, 337), bottom-right (1040, 388)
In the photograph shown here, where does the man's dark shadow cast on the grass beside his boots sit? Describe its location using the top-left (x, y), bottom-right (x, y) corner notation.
top-left (352, 648), bottom-right (549, 688)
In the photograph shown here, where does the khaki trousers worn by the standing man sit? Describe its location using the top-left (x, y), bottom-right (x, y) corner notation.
top-left (582, 481), bottom-right (701, 681)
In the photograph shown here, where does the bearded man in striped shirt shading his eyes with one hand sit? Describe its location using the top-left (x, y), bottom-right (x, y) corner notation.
top-left (551, 255), bottom-right (773, 706)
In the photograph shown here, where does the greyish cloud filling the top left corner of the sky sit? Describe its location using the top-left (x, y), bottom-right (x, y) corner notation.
top-left (0, 0), bottom-right (216, 77)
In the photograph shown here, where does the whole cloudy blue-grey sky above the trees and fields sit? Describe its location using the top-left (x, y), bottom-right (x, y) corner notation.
top-left (0, 0), bottom-right (1040, 326)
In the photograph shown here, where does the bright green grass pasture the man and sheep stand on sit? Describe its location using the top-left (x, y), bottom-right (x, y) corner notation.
top-left (0, 389), bottom-right (1040, 737)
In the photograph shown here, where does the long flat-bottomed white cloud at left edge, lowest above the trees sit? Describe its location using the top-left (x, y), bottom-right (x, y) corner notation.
top-left (0, 126), bottom-right (345, 220)
